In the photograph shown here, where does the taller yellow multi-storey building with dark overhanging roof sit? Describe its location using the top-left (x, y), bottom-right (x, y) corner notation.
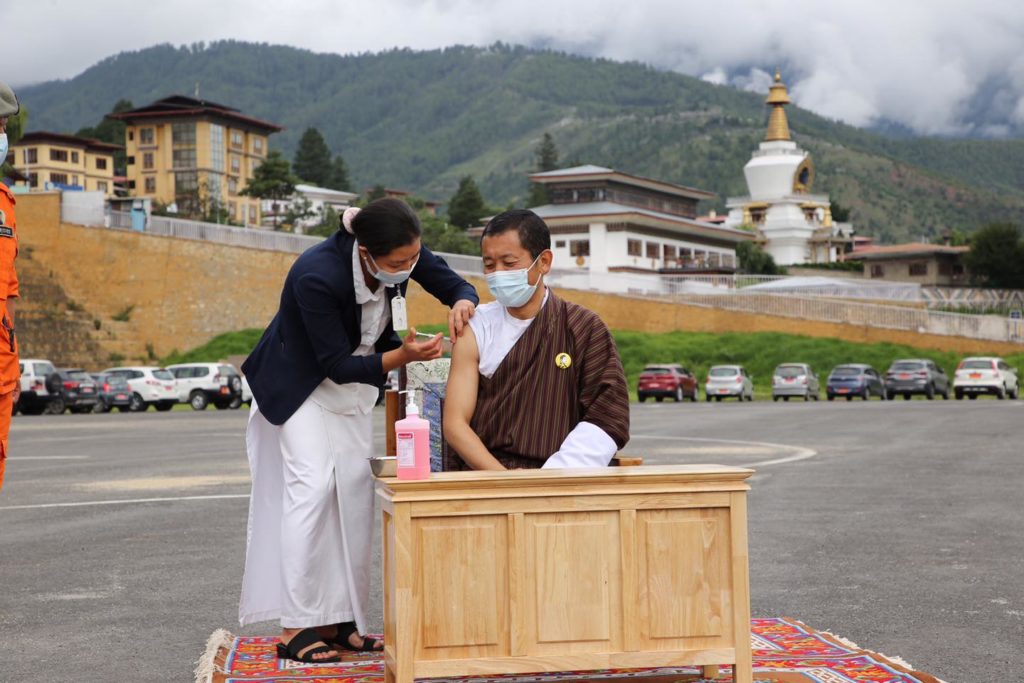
top-left (109, 95), bottom-right (282, 225)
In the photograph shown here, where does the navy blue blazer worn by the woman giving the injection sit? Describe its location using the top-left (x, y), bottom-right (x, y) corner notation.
top-left (242, 230), bottom-right (480, 425)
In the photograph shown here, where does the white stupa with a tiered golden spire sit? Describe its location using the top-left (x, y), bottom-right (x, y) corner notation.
top-left (725, 72), bottom-right (853, 265)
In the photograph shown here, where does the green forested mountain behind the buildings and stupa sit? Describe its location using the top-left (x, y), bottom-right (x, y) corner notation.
top-left (19, 42), bottom-right (1024, 242)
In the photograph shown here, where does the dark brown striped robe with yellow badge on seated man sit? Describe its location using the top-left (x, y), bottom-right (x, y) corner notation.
top-left (444, 292), bottom-right (630, 470)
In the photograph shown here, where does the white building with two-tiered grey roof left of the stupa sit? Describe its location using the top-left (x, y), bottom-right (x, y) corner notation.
top-left (529, 166), bottom-right (751, 278)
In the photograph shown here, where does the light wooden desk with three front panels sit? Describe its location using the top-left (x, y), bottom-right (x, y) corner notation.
top-left (377, 465), bottom-right (753, 683)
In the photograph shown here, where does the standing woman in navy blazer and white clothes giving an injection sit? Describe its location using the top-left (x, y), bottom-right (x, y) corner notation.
top-left (239, 199), bottom-right (479, 663)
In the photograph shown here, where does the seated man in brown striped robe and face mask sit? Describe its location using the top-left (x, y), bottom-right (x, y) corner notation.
top-left (443, 209), bottom-right (630, 470)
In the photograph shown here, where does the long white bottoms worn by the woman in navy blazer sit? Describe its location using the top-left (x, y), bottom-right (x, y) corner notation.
top-left (239, 389), bottom-right (376, 633)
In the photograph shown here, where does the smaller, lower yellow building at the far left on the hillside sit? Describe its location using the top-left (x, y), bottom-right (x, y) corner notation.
top-left (10, 131), bottom-right (122, 197)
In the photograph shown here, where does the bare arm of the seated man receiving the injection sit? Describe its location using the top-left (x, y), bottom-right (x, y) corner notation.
top-left (444, 326), bottom-right (505, 470)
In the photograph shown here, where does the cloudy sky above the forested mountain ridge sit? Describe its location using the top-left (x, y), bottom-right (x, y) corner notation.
top-left (8, 0), bottom-right (1024, 136)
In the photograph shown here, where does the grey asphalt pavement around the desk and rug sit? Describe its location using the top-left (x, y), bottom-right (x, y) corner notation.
top-left (0, 400), bottom-right (1024, 683)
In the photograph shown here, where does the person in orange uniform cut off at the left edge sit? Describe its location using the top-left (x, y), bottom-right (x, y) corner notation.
top-left (0, 83), bottom-right (22, 488)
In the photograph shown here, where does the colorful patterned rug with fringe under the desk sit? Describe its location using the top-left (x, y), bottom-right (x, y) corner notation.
top-left (196, 618), bottom-right (942, 683)
